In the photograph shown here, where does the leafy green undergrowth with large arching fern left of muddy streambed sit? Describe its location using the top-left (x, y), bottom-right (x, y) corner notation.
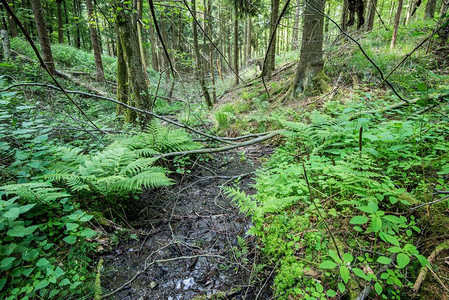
top-left (0, 82), bottom-right (200, 299)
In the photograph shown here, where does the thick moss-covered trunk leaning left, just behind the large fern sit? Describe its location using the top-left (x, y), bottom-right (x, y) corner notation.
top-left (117, 2), bottom-right (152, 124)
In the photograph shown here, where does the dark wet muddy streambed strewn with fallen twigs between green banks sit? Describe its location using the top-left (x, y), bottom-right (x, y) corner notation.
top-left (102, 145), bottom-right (271, 300)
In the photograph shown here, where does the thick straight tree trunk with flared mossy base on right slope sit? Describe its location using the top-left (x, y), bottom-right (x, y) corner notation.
top-left (293, 0), bottom-right (325, 94)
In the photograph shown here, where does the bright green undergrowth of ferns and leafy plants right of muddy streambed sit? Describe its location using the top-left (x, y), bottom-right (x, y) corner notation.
top-left (227, 95), bottom-right (449, 299)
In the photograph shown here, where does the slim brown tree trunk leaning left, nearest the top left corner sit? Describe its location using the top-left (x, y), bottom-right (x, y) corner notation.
top-left (31, 0), bottom-right (55, 75)
